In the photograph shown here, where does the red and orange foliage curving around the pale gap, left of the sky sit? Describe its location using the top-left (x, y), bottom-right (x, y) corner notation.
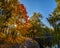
top-left (17, 4), bottom-right (30, 31)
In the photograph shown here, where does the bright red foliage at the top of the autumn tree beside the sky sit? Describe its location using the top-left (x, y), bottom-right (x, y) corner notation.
top-left (18, 4), bottom-right (29, 24)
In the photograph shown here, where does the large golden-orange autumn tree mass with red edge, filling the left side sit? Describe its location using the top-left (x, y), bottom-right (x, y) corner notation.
top-left (0, 0), bottom-right (29, 43)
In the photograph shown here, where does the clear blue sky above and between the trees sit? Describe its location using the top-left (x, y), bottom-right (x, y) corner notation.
top-left (19, 0), bottom-right (56, 27)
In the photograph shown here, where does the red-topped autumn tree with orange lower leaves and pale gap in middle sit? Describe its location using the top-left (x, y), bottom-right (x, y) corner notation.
top-left (17, 4), bottom-right (29, 35)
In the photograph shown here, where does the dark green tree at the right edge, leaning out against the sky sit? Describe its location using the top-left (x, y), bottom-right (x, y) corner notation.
top-left (47, 0), bottom-right (60, 44)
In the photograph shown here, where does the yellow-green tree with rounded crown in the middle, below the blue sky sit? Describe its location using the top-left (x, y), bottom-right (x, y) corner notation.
top-left (28, 12), bottom-right (43, 38)
